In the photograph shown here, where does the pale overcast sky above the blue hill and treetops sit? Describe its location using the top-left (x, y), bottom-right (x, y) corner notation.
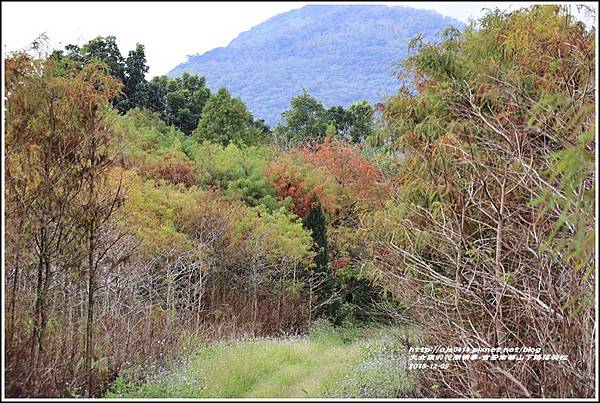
top-left (2, 1), bottom-right (596, 78)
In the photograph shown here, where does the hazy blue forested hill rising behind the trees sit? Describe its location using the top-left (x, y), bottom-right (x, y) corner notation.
top-left (168, 5), bottom-right (464, 125)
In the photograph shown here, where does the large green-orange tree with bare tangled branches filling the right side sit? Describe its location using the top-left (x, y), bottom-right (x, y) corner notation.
top-left (365, 5), bottom-right (596, 397)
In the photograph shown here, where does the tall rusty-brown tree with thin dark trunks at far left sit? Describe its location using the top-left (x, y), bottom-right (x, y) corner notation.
top-left (5, 45), bottom-right (122, 395)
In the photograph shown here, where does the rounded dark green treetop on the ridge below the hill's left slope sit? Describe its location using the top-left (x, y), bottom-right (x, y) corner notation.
top-left (193, 88), bottom-right (259, 146)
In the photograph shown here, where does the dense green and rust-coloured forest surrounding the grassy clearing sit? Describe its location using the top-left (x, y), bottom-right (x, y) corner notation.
top-left (3, 5), bottom-right (597, 397)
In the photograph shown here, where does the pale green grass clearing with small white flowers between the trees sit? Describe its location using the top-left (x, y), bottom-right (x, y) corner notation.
top-left (105, 322), bottom-right (415, 398)
